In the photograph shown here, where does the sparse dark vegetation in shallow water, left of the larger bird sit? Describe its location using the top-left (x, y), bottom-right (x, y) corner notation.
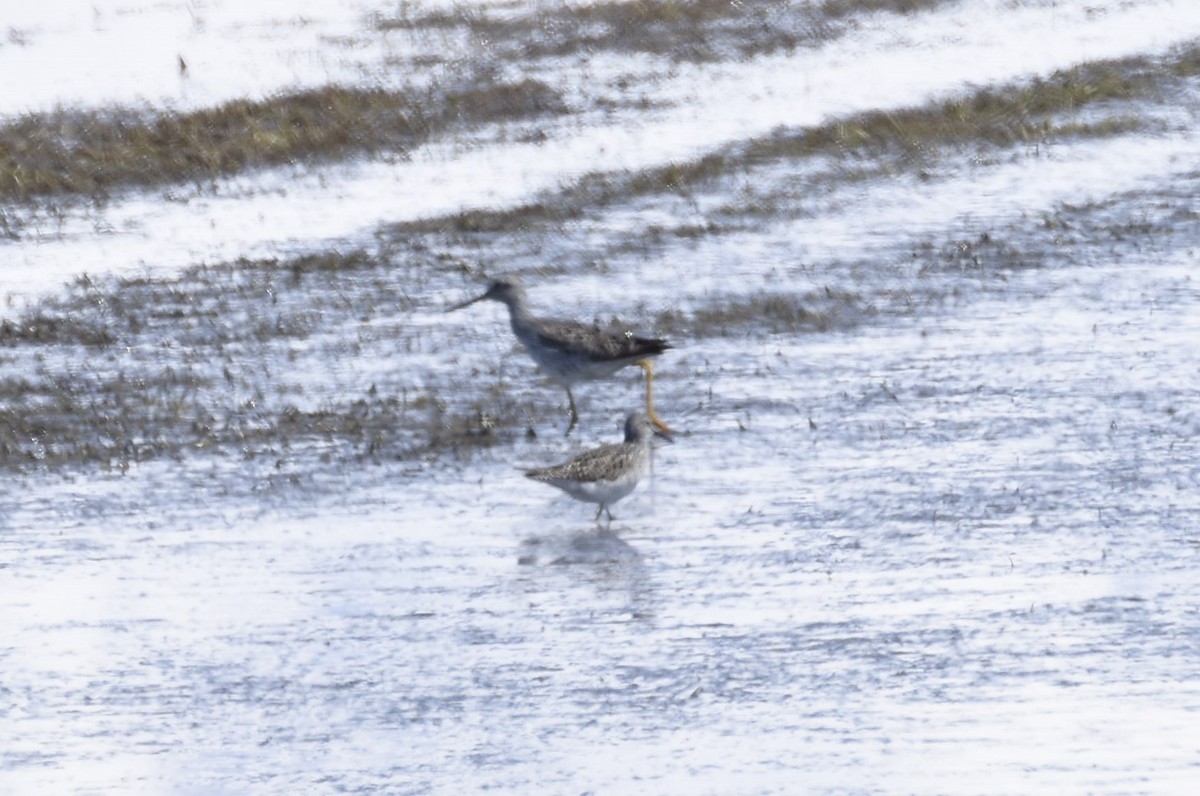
top-left (0, 250), bottom-right (534, 471)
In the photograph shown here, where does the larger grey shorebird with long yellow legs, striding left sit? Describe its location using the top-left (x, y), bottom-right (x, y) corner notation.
top-left (448, 277), bottom-right (671, 433)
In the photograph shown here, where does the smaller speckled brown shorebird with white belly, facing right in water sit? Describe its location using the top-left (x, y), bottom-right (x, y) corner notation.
top-left (526, 412), bottom-right (671, 522)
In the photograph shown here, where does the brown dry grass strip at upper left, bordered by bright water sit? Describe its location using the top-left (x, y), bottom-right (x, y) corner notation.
top-left (0, 80), bottom-right (565, 199)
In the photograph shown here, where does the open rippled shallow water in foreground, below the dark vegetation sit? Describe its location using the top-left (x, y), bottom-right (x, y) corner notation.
top-left (4, 229), bottom-right (1200, 792)
